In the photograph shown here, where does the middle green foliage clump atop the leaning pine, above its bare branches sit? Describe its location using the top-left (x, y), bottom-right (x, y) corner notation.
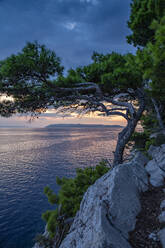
top-left (76, 52), bottom-right (142, 94)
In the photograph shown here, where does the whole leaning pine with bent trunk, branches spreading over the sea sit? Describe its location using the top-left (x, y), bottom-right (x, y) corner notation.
top-left (0, 43), bottom-right (145, 165)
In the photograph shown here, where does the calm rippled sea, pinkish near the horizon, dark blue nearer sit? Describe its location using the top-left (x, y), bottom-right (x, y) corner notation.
top-left (0, 127), bottom-right (120, 248)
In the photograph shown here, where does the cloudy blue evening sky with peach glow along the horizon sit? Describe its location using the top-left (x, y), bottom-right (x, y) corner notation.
top-left (0, 0), bottom-right (135, 126)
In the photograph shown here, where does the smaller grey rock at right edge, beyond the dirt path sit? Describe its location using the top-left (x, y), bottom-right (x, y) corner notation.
top-left (146, 144), bottom-right (165, 187)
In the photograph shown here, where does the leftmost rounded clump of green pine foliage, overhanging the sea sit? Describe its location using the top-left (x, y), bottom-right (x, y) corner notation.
top-left (0, 42), bottom-right (63, 115)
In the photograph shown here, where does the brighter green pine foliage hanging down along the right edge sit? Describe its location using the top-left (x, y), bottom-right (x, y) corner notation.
top-left (132, 16), bottom-right (165, 130)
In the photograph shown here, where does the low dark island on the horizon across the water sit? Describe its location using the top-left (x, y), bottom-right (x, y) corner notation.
top-left (45, 124), bottom-right (122, 128)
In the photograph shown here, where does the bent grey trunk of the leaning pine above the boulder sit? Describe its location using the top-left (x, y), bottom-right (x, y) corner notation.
top-left (113, 90), bottom-right (145, 166)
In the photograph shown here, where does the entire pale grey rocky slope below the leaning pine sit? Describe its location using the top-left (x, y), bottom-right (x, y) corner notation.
top-left (34, 145), bottom-right (165, 248)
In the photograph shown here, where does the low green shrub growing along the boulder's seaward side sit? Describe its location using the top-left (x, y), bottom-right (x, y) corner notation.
top-left (42, 161), bottom-right (109, 237)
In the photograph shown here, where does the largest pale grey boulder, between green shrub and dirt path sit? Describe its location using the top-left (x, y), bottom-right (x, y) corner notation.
top-left (60, 153), bottom-right (148, 248)
